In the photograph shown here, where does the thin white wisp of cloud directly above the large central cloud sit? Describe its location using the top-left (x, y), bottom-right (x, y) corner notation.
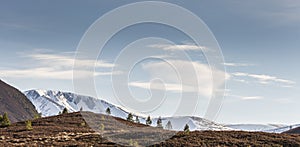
top-left (149, 44), bottom-right (207, 51)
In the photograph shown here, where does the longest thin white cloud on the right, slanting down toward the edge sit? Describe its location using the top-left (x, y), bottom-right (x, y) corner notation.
top-left (232, 72), bottom-right (295, 86)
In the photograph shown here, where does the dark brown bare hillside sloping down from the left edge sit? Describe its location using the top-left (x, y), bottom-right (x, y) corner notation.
top-left (0, 80), bottom-right (38, 122)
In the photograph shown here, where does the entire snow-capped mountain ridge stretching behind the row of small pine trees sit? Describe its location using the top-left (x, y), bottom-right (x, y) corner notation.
top-left (24, 90), bottom-right (230, 131)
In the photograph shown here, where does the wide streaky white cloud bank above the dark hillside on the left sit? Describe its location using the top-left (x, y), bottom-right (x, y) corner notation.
top-left (0, 49), bottom-right (121, 80)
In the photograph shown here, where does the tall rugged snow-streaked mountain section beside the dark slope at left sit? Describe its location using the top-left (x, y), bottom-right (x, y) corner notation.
top-left (24, 90), bottom-right (128, 118)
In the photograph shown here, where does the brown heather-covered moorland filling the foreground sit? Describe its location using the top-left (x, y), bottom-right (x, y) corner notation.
top-left (0, 112), bottom-right (300, 147)
